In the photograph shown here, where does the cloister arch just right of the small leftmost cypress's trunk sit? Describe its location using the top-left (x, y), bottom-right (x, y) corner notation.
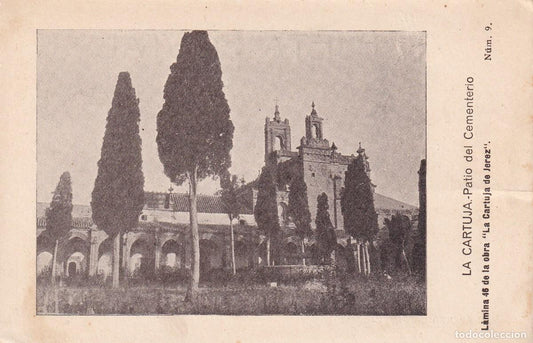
top-left (61, 235), bottom-right (90, 277)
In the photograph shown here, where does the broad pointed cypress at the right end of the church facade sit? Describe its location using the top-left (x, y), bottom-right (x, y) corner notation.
top-left (341, 155), bottom-right (378, 274)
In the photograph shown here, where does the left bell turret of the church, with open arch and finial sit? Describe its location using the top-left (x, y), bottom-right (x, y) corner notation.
top-left (265, 105), bottom-right (291, 163)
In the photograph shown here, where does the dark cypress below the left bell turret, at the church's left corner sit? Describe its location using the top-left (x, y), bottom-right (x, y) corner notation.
top-left (254, 165), bottom-right (281, 265)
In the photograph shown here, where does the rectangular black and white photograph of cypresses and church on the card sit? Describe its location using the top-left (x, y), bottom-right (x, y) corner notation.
top-left (35, 29), bottom-right (426, 316)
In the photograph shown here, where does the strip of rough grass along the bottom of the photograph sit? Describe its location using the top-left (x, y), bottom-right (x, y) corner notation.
top-left (37, 276), bottom-right (426, 315)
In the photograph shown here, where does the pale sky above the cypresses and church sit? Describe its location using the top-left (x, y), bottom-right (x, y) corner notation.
top-left (37, 30), bottom-right (426, 206)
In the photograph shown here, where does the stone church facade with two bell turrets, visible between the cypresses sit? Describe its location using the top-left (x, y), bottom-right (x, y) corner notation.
top-left (258, 103), bottom-right (418, 246)
